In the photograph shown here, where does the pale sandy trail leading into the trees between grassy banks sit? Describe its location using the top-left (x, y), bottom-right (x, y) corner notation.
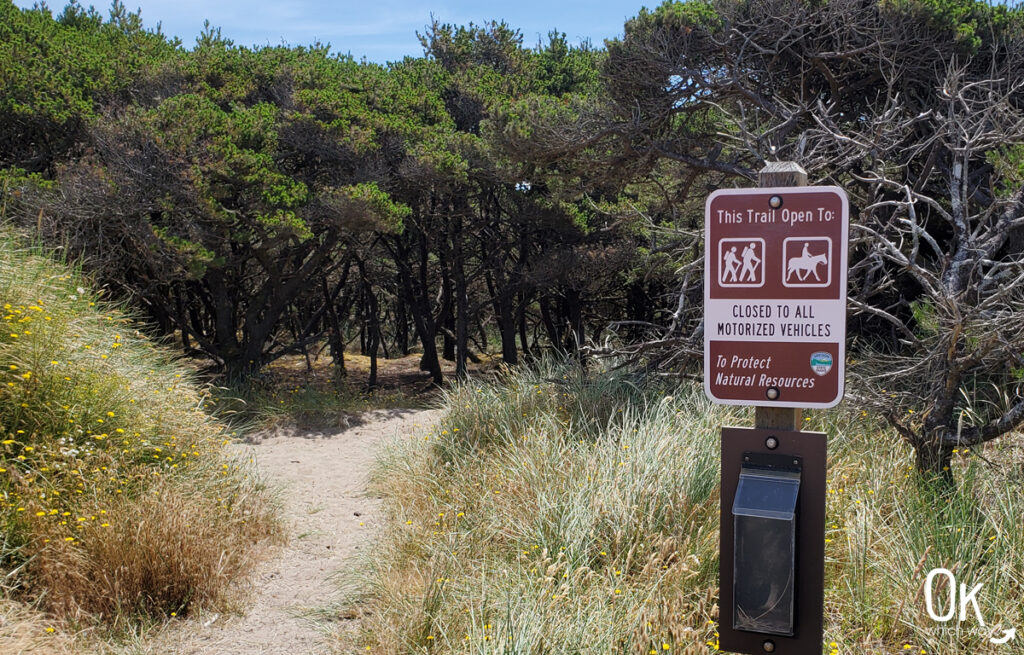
top-left (151, 409), bottom-right (439, 655)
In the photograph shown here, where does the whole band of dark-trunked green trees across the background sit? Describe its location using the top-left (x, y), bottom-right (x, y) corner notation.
top-left (0, 0), bottom-right (1024, 472)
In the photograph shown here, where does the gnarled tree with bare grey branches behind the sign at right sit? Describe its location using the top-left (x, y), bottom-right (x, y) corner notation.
top-left (585, 0), bottom-right (1024, 472)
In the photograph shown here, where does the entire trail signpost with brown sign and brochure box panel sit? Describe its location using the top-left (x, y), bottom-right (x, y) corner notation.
top-left (705, 162), bottom-right (849, 655)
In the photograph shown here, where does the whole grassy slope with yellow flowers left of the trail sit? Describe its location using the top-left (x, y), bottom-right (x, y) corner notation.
top-left (0, 233), bottom-right (282, 653)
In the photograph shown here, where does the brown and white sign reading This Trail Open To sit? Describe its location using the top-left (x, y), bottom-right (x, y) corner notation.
top-left (705, 186), bottom-right (850, 407)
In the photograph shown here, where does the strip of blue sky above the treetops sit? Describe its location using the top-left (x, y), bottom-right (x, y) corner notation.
top-left (14, 0), bottom-right (647, 62)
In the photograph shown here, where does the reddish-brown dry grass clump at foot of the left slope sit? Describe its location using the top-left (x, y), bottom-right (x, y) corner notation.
top-left (26, 470), bottom-right (280, 628)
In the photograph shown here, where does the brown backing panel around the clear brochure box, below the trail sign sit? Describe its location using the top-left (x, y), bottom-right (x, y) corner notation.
top-left (718, 428), bottom-right (826, 655)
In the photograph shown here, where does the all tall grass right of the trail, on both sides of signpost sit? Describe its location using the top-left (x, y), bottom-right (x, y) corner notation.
top-left (354, 366), bottom-right (1024, 655)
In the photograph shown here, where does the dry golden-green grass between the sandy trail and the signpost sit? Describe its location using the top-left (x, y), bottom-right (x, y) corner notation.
top-left (345, 372), bottom-right (718, 654)
